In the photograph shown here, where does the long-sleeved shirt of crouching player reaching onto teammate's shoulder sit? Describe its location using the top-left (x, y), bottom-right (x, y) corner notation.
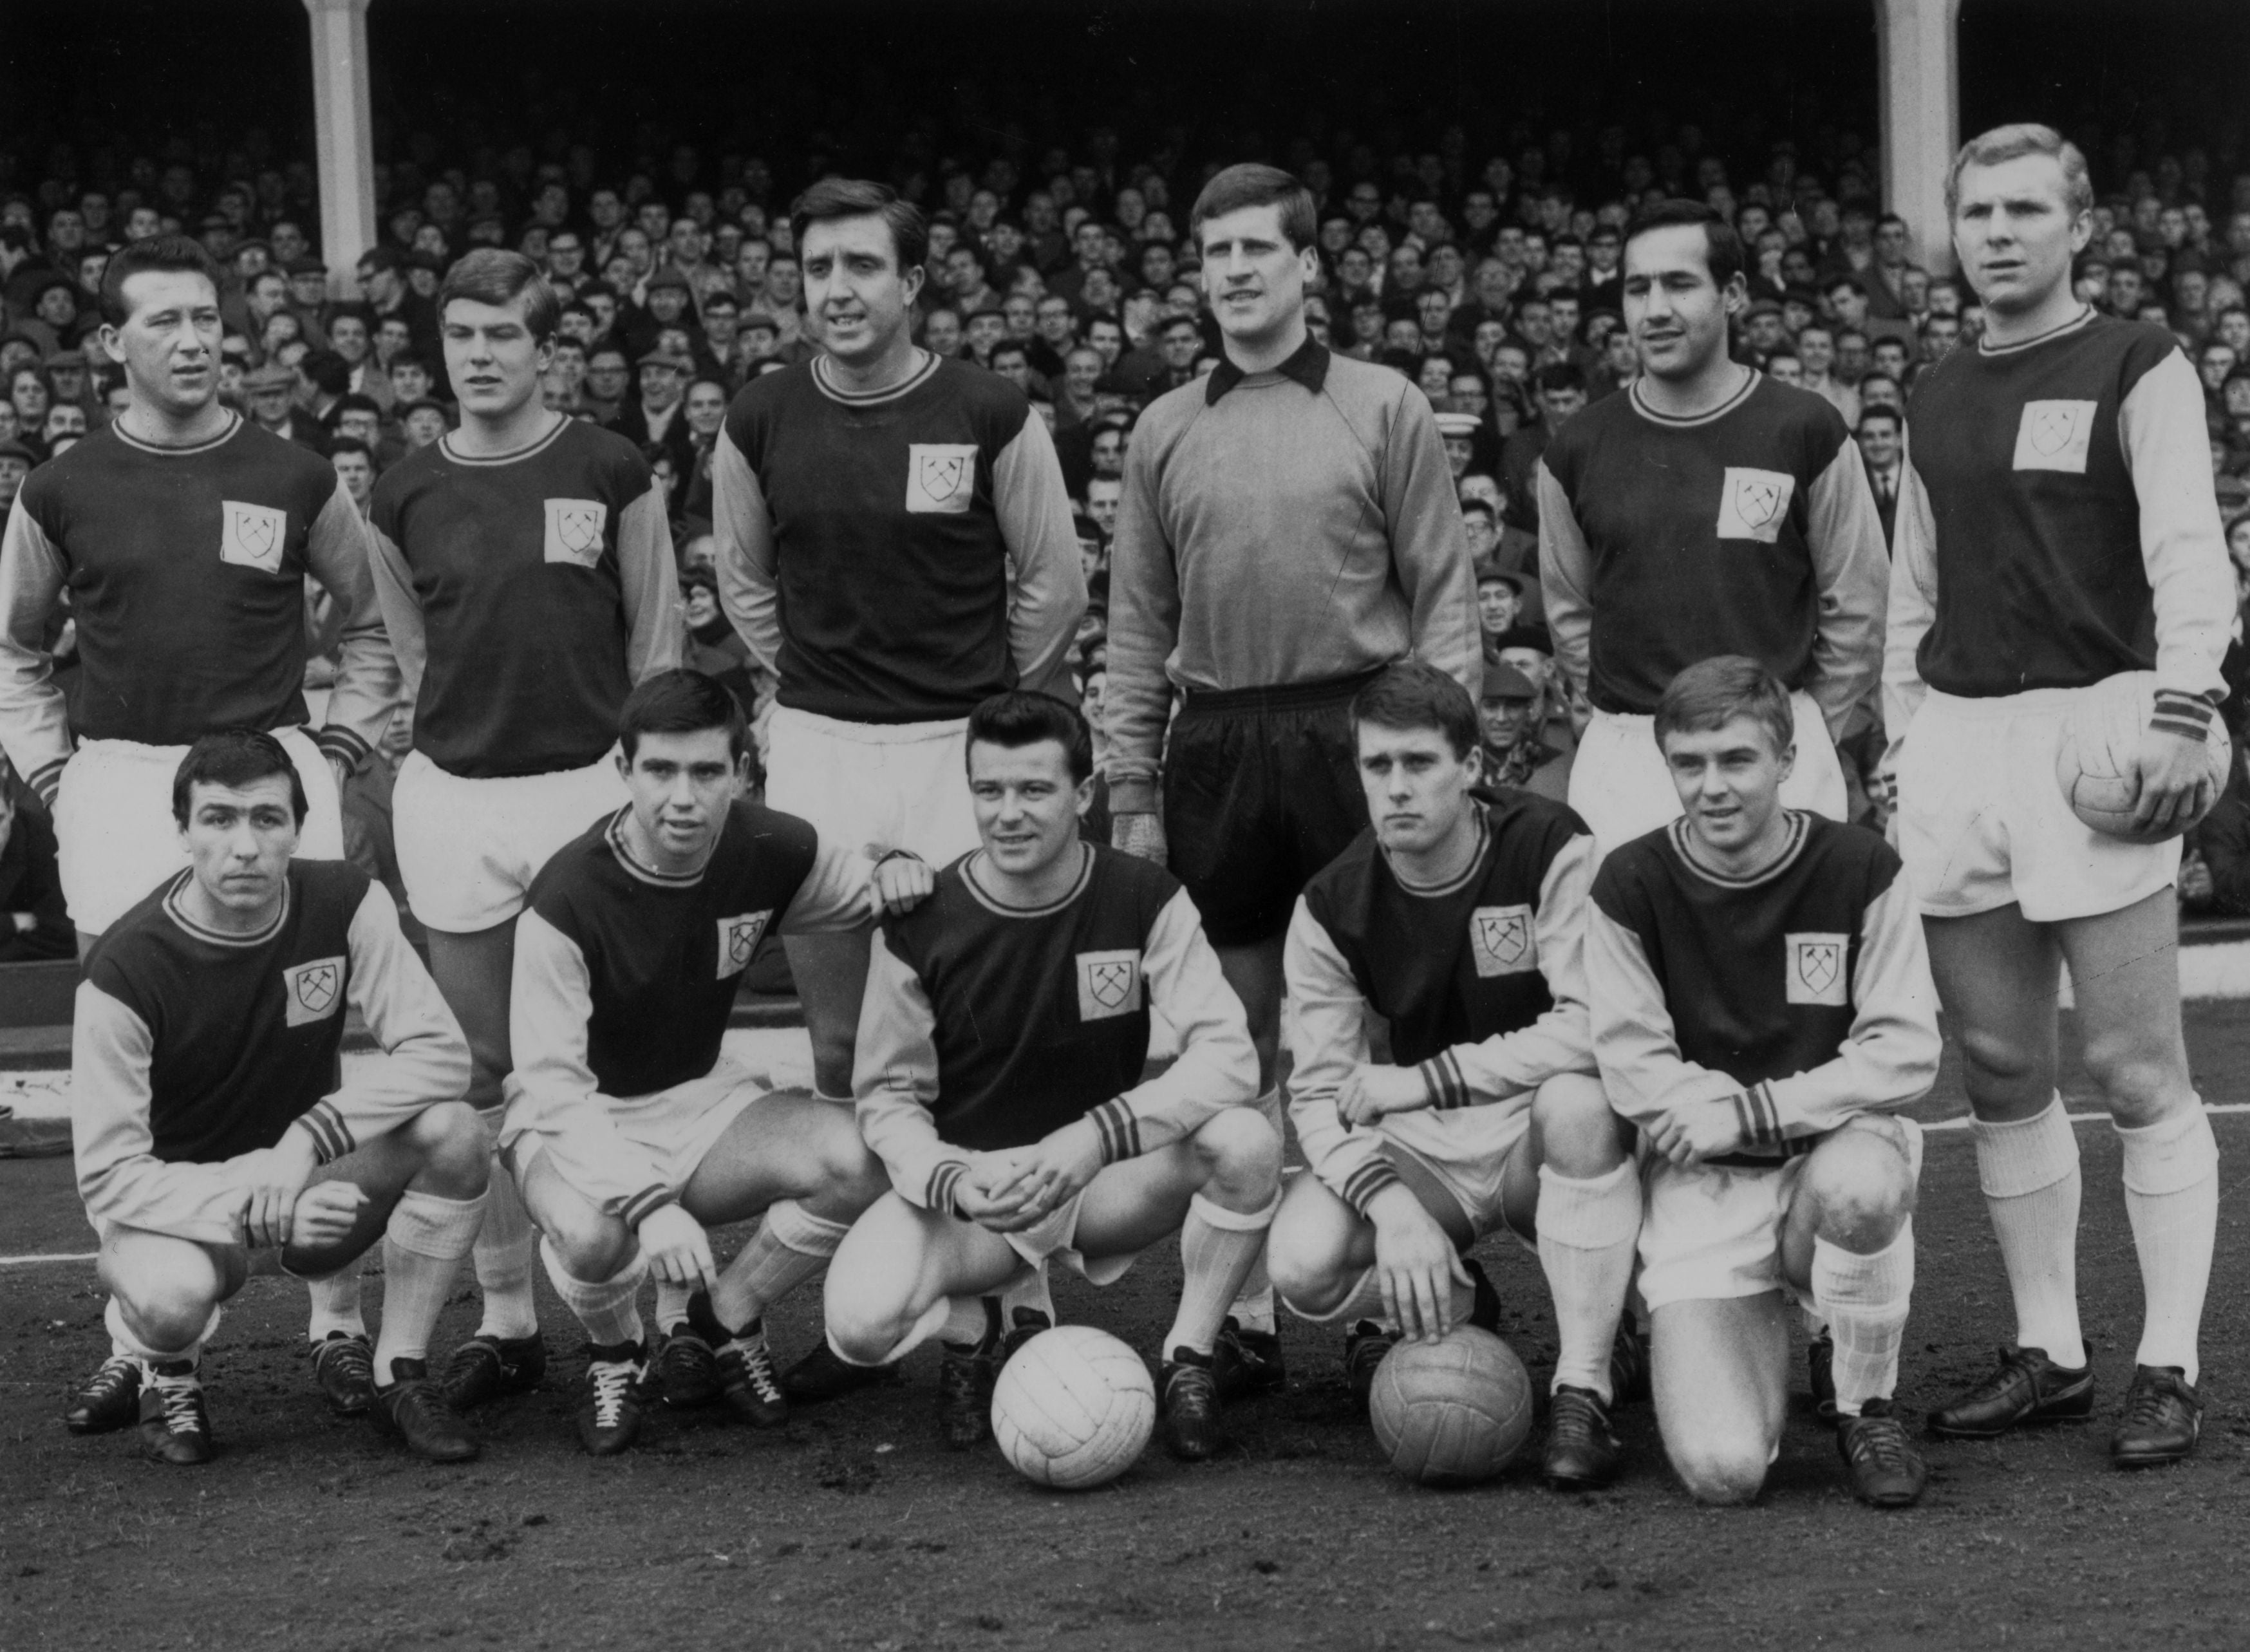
top-left (500, 803), bottom-right (873, 1225)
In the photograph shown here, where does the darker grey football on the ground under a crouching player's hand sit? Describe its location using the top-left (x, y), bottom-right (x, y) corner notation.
top-left (1368, 1326), bottom-right (1532, 1485)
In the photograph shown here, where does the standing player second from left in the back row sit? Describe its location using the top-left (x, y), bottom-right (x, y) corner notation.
top-left (369, 248), bottom-right (682, 1409)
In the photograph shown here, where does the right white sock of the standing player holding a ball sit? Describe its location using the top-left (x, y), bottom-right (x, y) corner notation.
top-left (2117, 1101), bottom-right (2218, 1382)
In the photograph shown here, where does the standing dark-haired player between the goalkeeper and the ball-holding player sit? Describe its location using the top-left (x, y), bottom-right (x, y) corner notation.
top-left (1537, 200), bottom-right (1886, 853)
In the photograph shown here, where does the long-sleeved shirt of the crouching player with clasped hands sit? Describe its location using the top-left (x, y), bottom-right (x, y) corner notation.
top-left (853, 844), bottom-right (1258, 1211)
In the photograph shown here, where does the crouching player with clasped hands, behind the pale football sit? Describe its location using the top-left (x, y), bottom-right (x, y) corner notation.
top-left (828, 693), bottom-right (1280, 1461)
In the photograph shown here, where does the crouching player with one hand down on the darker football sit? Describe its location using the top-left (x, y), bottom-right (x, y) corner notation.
top-left (1267, 662), bottom-right (1642, 1488)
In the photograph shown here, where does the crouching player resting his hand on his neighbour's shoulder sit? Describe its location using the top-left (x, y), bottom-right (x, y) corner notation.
top-left (502, 671), bottom-right (932, 1456)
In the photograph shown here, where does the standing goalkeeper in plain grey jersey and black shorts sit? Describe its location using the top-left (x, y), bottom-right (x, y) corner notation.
top-left (1103, 164), bottom-right (1481, 1393)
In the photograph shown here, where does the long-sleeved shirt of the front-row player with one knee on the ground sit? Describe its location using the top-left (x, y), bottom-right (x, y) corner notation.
top-left (1586, 812), bottom-right (1940, 1163)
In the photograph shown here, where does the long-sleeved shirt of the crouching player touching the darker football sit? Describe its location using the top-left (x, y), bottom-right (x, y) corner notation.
top-left (1282, 793), bottom-right (1593, 1211)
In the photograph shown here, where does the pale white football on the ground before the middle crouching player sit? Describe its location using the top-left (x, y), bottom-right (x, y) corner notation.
top-left (992, 1326), bottom-right (1156, 1492)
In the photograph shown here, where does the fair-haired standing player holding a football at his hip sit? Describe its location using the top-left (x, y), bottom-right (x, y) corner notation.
top-left (1883, 126), bottom-right (2235, 1467)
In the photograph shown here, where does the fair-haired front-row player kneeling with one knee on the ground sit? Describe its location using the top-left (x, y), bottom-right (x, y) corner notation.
top-left (1586, 655), bottom-right (1940, 1508)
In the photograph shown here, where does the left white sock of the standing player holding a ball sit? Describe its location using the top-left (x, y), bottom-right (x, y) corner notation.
top-left (1969, 1094), bottom-right (2086, 1371)
